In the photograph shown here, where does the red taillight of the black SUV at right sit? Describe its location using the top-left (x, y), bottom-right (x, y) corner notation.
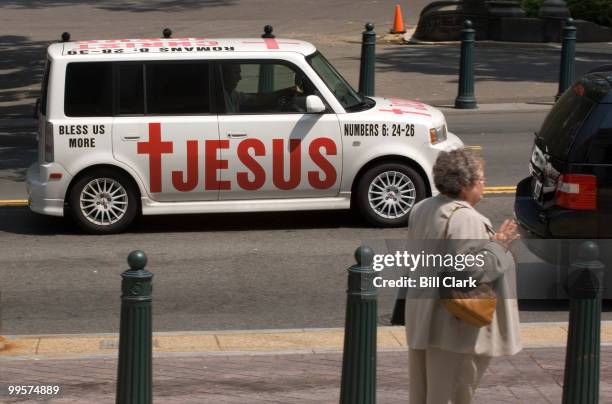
top-left (556, 174), bottom-right (597, 210)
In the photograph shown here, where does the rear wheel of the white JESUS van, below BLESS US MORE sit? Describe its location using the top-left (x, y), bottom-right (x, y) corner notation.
top-left (68, 170), bottom-right (138, 234)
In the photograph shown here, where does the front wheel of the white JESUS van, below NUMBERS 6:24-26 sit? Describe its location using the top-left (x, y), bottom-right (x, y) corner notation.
top-left (357, 163), bottom-right (426, 227)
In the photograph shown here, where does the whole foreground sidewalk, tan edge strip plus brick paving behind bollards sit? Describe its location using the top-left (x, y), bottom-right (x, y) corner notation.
top-left (0, 321), bottom-right (612, 404)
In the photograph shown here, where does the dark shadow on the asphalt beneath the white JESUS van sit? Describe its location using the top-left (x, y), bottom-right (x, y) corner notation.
top-left (0, 206), bottom-right (368, 236)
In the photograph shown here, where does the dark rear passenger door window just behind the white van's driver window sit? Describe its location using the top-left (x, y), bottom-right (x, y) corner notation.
top-left (145, 62), bottom-right (210, 115)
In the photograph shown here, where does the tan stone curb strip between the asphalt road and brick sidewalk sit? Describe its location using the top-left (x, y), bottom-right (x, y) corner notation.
top-left (0, 321), bottom-right (612, 361)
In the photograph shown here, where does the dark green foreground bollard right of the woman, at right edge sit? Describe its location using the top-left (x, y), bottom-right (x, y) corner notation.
top-left (562, 241), bottom-right (604, 404)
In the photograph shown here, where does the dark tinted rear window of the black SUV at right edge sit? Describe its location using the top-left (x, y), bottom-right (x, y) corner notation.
top-left (536, 84), bottom-right (596, 159)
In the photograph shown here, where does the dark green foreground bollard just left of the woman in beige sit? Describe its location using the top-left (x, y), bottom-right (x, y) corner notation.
top-left (340, 246), bottom-right (378, 404)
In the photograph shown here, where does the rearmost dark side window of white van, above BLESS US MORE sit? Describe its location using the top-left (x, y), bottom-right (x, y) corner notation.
top-left (64, 62), bottom-right (113, 116)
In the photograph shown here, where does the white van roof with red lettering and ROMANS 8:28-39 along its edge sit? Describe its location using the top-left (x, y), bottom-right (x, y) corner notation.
top-left (49, 38), bottom-right (316, 58)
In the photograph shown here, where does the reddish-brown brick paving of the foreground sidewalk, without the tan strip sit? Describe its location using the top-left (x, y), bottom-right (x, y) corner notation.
top-left (0, 346), bottom-right (612, 404)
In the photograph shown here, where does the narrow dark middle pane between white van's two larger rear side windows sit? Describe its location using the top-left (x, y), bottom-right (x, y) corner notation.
top-left (118, 63), bottom-right (144, 115)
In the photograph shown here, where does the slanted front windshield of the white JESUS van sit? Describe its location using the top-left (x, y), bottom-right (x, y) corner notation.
top-left (306, 52), bottom-right (366, 111)
